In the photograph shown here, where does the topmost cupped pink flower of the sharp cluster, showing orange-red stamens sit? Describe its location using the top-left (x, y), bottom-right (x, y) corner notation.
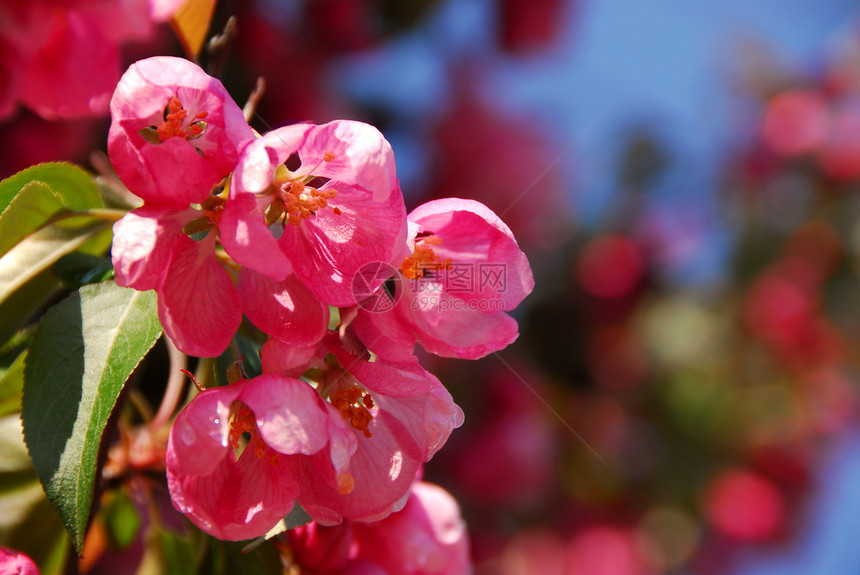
top-left (108, 56), bottom-right (254, 207)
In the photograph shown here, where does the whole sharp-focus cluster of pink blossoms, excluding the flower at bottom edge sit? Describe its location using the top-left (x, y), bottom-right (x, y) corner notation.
top-left (108, 57), bottom-right (534, 548)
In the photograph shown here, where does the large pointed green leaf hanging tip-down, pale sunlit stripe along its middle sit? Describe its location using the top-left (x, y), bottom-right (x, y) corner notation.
top-left (21, 282), bottom-right (161, 552)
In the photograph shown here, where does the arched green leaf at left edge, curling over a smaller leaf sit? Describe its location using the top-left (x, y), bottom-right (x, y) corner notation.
top-left (0, 162), bottom-right (103, 212)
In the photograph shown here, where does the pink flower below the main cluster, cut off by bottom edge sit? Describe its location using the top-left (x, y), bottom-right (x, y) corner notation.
top-left (287, 481), bottom-right (471, 575)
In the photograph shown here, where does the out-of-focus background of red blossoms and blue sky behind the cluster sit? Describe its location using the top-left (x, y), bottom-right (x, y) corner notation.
top-left (8, 0), bottom-right (860, 575)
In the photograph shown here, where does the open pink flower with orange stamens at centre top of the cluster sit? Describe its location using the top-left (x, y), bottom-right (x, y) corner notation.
top-left (221, 120), bottom-right (407, 306)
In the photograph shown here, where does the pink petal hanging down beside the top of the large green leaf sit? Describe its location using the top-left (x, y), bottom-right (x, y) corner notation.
top-left (158, 232), bottom-right (242, 357)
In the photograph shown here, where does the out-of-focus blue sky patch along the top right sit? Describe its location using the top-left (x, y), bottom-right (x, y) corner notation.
top-left (330, 0), bottom-right (857, 283)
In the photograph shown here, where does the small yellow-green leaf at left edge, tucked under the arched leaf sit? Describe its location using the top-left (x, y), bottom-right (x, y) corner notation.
top-left (0, 182), bottom-right (63, 256)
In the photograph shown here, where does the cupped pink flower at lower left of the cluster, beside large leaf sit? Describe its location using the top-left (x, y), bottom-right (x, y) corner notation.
top-left (166, 374), bottom-right (356, 540)
